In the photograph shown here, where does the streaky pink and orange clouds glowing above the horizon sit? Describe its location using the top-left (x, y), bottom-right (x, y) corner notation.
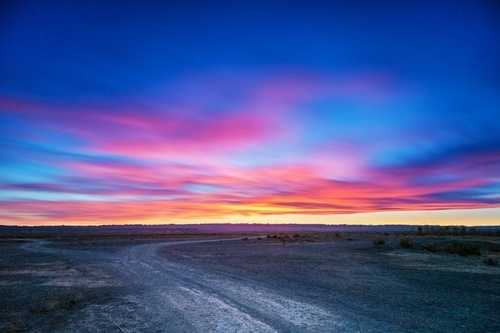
top-left (0, 71), bottom-right (500, 223)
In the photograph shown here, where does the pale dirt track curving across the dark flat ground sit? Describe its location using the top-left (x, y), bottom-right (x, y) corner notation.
top-left (26, 238), bottom-right (346, 332)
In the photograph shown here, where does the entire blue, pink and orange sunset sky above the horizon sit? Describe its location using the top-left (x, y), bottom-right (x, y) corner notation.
top-left (0, 0), bottom-right (500, 225)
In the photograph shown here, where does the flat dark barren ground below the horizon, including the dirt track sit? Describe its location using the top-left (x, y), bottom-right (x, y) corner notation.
top-left (0, 233), bottom-right (500, 332)
